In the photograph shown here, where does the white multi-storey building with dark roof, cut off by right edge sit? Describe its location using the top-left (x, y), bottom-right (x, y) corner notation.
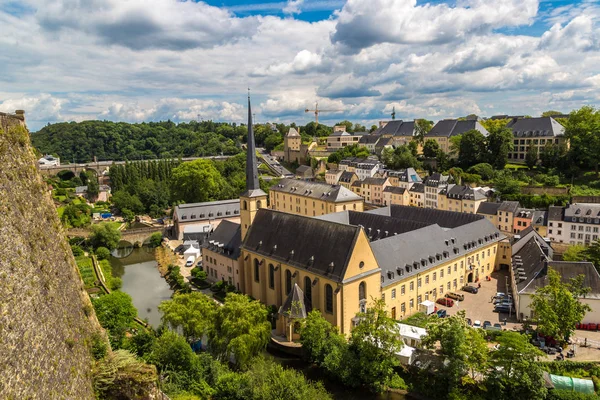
top-left (548, 203), bottom-right (600, 245)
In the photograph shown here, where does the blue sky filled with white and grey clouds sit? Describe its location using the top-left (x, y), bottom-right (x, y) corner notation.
top-left (0, 0), bottom-right (600, 131)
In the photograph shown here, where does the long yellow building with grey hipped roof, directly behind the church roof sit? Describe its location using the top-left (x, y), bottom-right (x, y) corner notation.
top-left (269, 179), bottom-right (364, 217)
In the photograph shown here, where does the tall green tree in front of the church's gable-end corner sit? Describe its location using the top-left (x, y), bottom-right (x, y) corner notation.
top-left (348, 299), bottom-right (402, 392)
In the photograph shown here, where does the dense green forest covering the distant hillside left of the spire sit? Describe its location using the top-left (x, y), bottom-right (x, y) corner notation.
top-left (31, 121), bottom-right (247, 163)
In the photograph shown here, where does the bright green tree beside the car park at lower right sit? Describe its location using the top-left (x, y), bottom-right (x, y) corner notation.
top-left (530, 268), bottom-right (591, 341)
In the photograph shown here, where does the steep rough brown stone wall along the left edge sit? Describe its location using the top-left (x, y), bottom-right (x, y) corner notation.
top-left (0, 113), bottom-right (99, 399)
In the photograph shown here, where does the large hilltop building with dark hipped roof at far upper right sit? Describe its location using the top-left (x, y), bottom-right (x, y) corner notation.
top-left (507, 117), bottom-right (568, 162)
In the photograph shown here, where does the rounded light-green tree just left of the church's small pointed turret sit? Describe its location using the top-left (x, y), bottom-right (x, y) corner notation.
top-left (208, 293), bottom-right (271, 368)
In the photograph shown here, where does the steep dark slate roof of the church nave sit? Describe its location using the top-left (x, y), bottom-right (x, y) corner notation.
top-left (242, 208), bottom-right (360, 282)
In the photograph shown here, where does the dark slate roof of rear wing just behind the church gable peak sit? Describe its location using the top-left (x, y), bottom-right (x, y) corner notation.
top-left (316, 211), bottom-right (433, 241)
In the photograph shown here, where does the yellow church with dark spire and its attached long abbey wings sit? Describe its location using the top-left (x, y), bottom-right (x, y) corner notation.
top-left (202, 99), bottom-right (511, 340)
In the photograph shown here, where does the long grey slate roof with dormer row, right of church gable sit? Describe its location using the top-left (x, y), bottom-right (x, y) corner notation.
top-left (371, 218), bottom-right (505, 287)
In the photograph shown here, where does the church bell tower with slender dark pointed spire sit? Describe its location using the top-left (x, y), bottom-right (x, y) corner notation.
top-left (240, 93), bottom-right (267, 240)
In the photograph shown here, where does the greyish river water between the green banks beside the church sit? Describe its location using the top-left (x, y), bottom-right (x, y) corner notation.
top-left (110, 248), bottom-right (173, 328)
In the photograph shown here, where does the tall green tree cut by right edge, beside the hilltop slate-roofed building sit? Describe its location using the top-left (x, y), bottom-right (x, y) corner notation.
top-left (565, 106), bottom-right (600, 176)
